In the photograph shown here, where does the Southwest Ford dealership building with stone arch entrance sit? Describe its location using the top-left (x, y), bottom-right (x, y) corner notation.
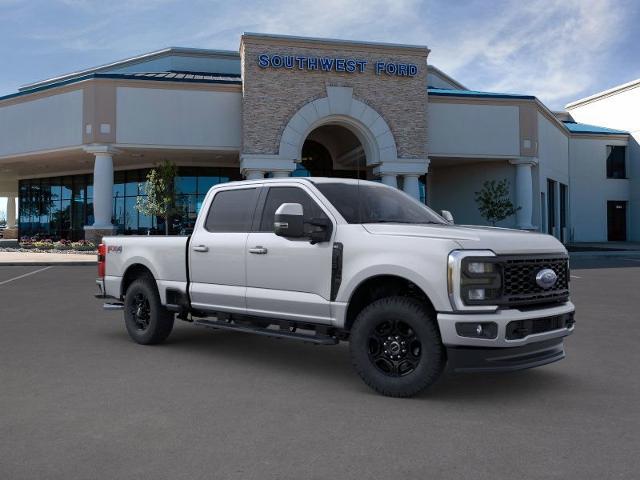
top-left (0, 33), bottom-right (640, 242)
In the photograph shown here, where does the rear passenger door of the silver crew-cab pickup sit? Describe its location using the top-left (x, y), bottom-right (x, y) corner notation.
top-left (189, 186), bottom-right (259, 313)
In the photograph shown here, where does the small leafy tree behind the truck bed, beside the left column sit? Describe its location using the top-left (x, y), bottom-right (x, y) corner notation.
top-left (136, 160), bottom-right (178, 235)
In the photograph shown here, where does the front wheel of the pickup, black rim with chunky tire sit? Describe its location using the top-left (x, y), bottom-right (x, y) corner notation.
top-left (350, 297), bottom-right (446, 397)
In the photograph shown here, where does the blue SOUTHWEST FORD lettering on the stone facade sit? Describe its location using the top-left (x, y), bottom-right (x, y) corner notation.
top-left (258, 53), bottom-right (418, 77)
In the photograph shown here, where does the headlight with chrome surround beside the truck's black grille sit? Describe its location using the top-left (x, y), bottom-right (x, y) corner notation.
top-left (447, 250), bottom-right (502, 311)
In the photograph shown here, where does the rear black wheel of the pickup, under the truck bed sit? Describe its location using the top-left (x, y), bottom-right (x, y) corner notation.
top-left (124, 277), bottom-right (174, 345)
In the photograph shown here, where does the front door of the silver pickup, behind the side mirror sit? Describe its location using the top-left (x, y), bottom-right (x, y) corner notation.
top-left (247, 185), bottom-right (335, 323)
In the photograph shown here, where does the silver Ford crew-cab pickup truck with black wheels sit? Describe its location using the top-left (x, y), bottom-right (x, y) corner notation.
top-left (97, 178), bottom-right (574, 396)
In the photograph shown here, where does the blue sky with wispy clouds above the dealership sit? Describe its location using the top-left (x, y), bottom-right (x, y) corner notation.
top-left (0, 0), bottom-right (640, 215)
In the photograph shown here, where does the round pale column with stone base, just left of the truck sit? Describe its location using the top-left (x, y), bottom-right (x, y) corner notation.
top-left (84, 145), bottom-right (116, 242)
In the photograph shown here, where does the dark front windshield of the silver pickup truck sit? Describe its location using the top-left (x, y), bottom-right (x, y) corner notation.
top-left (316, 183), bottom-right (446, 224)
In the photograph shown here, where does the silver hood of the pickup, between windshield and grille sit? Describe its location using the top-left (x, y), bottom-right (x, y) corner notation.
top-left (363, 223), bottom-right (566, 254)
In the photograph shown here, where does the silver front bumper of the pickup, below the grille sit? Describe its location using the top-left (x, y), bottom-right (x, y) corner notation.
top-left (438, 302), bottom-right (575, 348)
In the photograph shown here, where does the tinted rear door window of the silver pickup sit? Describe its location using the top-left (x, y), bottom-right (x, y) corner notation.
top-left (204, 188), bottom-right (258, 232)
